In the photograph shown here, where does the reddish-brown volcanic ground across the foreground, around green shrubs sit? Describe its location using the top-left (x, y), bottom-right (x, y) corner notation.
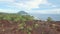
top-left (0, 20), bottom-right (60, 34)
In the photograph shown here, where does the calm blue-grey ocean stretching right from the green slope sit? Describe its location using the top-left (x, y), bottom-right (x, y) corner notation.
top-left (32, 14), bottom-right (60, 21)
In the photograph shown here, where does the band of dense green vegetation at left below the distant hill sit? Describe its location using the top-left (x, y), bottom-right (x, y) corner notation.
top-left (0, 12), bottom-right (34, 21)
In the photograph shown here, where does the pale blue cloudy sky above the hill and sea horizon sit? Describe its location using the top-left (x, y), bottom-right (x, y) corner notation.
top-left (0, 0), bottom-right (60, 14)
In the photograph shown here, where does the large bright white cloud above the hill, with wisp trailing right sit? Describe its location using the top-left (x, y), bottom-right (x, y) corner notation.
top-left (4, 0), bottom-right (52, 10)
